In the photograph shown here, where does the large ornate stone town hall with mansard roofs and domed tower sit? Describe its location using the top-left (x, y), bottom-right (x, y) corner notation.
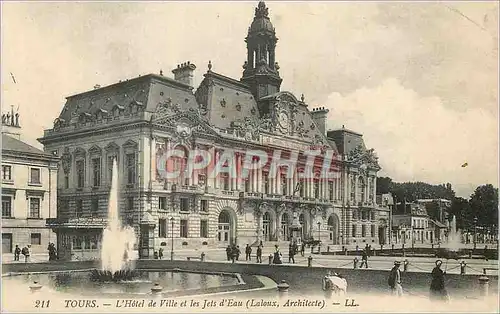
top-left (39, 2), bottom-right (390, 260)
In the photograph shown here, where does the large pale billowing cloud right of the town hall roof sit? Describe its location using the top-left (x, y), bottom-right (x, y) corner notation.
top-left (325, 79), bottom-right (498, 196)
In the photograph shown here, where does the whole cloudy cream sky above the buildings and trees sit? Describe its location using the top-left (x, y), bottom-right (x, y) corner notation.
top-left (1, 1), bottom-right (498, 198)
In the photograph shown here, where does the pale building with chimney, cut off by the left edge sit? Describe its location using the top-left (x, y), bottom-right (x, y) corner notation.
top-left (2, 110), bottom-right (59, 253)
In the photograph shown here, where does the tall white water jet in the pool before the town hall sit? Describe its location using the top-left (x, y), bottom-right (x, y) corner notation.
top-left (91, 159), bottom-right (136, 281)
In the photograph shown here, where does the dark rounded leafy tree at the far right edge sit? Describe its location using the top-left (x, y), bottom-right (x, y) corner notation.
top-left (469, 184), bottom-right (498, 232)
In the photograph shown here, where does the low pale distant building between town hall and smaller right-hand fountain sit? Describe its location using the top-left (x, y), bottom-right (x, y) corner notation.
top-left (392, 203), bottom-right (447, 245)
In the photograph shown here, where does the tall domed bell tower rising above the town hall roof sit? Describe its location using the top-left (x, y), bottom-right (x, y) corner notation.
top-left (241, 1), bottom-right (282, 100)
